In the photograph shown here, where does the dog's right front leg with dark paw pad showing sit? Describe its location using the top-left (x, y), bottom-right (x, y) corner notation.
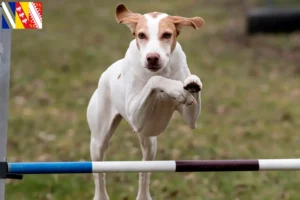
top-left (178, 75), bottom-right (202, 129)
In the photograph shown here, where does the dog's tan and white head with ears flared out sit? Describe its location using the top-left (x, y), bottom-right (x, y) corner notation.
top-left (116, 4), bottom-right (204, 72)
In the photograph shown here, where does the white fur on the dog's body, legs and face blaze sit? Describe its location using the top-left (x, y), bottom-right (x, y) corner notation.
top-left (87, 14), bottom-right (202, 200)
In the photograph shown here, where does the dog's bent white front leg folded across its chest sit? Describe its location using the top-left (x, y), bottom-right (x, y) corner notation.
top-left (126, 76), bottom-right (195, 133)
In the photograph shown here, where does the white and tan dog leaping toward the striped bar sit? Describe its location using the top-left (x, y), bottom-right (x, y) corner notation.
top-left (87, 4), bottom-right (204, 200)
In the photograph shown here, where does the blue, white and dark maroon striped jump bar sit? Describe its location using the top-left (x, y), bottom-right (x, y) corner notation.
top-left (8, 159), bottom-right (300, 174)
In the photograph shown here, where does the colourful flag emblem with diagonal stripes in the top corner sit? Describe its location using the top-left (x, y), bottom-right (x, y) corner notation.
top-left (1, 2), bottom-right (43, 29)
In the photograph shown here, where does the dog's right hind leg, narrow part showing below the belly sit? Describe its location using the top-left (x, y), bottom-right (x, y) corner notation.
top-left (136, 134), bottom-right (157, 200)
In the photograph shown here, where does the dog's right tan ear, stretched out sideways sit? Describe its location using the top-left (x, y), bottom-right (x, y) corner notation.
top-left (169, 16), bottom-right (205, 35)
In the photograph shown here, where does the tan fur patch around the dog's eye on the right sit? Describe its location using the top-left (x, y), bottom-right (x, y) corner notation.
top-left (158, 17), bottom-right (178, 52)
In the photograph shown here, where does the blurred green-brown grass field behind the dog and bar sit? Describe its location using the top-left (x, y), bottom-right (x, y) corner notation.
top-left (6, 0), bottom-right (300, 200)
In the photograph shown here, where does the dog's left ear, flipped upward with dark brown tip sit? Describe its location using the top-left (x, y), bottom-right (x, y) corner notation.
top-left (116, 4), bottom-right (142, 35)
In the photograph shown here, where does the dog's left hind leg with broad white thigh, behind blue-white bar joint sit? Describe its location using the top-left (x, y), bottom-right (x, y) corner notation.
top-left (87, 88), bottom-right (122, 200)
